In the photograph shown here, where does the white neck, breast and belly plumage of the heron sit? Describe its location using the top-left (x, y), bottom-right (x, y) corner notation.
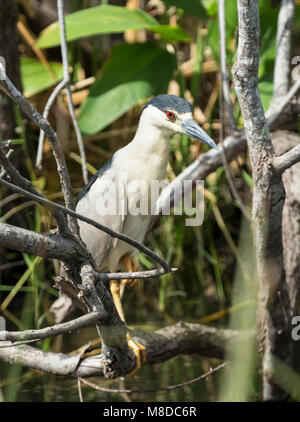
top-left (77, 123), bottom-right (170, 271)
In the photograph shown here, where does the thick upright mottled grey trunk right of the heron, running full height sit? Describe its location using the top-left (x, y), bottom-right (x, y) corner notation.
top-left (233, 0), bottom-right (292, 400)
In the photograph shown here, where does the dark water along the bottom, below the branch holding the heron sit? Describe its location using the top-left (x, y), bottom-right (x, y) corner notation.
top-left (0, 350), bottom-right (220, 402)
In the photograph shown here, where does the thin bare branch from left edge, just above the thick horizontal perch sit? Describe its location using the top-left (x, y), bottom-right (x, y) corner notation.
top-left (0, 309), bottom-right (106, 346)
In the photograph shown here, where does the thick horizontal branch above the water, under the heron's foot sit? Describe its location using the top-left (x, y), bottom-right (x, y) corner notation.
top-left (0, 322), bottom-right (255, 377)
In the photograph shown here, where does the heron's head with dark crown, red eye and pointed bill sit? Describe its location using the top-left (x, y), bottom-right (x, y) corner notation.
top-left (141, 94), bottom-right (218, 149)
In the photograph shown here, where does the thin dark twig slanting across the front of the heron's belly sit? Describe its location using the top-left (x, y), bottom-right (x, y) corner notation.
top-left (0, 178), bottom-right (171, 272)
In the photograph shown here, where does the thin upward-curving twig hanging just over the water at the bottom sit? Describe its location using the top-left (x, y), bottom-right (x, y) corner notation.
top-left (78, 361), bottom-right (228, 394)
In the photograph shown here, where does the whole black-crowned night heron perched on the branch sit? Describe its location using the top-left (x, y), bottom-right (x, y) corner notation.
top-left (76, 95), bottom-right (217, 367)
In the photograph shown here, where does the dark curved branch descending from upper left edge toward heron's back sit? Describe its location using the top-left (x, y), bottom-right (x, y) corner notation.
top-left (0, 63), bottom-right (79, 235)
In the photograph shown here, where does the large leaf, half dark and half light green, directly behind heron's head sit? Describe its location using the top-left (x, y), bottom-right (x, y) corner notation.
top-left (79, 42), bottom-right (176, 135)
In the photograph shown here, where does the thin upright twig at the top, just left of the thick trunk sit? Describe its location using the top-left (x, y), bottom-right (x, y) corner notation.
top-left (218, 0), bottom-right (236, 132)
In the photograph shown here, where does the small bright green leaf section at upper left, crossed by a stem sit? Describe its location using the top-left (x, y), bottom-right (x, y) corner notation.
top-left (21, 58), bottom-right (63, 97)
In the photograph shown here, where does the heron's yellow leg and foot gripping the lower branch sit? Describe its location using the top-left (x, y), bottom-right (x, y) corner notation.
top-left (110, 280), bottom-right (146, 375)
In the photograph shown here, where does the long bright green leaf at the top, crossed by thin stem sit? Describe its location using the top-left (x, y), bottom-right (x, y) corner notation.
top-left (37, 5), bottom-right (158, 48)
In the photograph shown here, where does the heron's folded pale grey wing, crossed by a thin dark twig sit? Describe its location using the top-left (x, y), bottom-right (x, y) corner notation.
top-left (76, 159), bottom-right (127, 270)
